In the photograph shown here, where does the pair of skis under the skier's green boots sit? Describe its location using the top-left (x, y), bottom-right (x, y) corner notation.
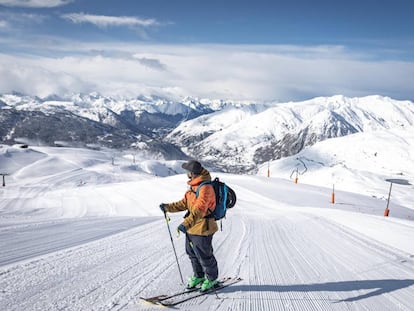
top-left (140, 277), bottom-right (241, 306)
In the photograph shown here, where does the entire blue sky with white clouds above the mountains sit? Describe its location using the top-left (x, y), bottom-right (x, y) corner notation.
top-left (0, 0), bottom-right (414, 101)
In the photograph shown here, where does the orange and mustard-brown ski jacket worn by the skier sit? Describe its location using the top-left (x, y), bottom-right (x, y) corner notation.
top-left (166, 169), bottom-right (218, 235)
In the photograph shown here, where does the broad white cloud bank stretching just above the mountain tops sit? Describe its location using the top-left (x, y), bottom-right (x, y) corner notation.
top-left (0, 41), bottom-right (414, 101)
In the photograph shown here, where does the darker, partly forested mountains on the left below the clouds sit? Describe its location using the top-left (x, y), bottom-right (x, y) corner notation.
top-left (0, 93), bottom-right (244, 159)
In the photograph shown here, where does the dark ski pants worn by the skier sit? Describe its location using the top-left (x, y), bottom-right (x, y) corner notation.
top-left (185, 233), bottom-right (218, 280)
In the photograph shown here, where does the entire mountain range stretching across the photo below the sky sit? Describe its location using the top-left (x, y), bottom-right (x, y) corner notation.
top-left (0, 93), bottom-right (414, 173)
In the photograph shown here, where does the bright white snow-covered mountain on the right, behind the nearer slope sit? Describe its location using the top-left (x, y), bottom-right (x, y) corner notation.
top-left (167, 96), bottom-right (414, 172)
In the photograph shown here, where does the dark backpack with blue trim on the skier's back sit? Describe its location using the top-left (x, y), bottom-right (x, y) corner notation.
top-left (196, 177), bottom-right (236, 220)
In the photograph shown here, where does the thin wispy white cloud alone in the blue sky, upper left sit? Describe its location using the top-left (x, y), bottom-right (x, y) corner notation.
top-left (62, 13), bottom-right (159, 27)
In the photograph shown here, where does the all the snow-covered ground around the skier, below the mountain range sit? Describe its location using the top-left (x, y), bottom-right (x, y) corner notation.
top-left (0, 145), bottom-right (414, 311)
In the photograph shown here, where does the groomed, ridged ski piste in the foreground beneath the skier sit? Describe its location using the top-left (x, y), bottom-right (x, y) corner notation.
top-left (0, 184), bottom-right (414, 311)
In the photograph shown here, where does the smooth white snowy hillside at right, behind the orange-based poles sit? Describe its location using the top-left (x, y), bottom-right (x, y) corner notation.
top-left (258, 127), bottom-right (414, 208)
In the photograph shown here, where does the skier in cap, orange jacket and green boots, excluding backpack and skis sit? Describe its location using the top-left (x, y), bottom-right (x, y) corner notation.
top-left (160, 160), bottom-right (218, 292)
